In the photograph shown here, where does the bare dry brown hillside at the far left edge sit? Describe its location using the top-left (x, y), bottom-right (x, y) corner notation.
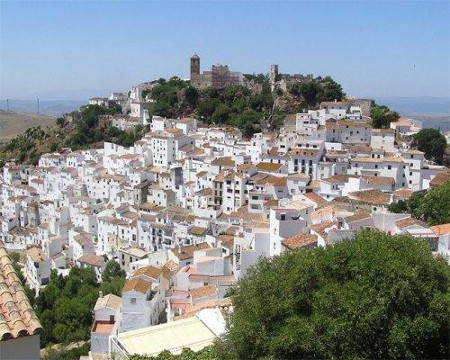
top-left (0, 110), bottom-right (55, 144)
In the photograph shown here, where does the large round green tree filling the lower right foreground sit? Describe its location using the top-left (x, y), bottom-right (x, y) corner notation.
top-left (220, 231), bottom-right (450, 359)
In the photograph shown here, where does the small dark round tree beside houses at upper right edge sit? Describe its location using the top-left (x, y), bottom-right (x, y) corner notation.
top-left (412, 129), bottom-right (447, 164)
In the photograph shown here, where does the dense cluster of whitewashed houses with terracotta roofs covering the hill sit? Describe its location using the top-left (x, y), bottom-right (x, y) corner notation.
top-left (0, 88), bottom-right (450, 358)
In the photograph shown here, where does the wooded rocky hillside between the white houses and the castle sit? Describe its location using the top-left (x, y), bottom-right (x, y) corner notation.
top-left (0, 74), bottom-right (344, 166)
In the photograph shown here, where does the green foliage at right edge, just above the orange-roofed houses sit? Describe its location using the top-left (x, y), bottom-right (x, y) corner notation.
top-left (389, 181), bottom-right (450, 225)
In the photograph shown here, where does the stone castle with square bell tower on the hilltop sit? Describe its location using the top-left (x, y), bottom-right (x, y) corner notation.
top-left (191, 54), bottom-right (244, 89)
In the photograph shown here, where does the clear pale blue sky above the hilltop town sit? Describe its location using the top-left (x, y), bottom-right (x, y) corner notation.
top-left (0, 0), bottom-right (450, 99)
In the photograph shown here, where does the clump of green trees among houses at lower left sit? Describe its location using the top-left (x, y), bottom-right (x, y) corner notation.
top-left (36, 263), bottom-right (125, 346)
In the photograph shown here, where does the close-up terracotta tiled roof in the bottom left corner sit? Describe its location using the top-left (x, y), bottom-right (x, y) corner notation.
top-left (0, 247), bottom-right (42, 340)
